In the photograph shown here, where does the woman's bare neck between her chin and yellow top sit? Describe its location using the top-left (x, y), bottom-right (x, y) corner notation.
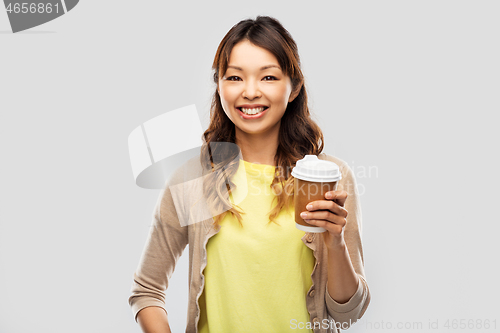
top-left (235, 127), bottom-right (279, 166)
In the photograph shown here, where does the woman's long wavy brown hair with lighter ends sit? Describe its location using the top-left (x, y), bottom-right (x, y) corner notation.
top-left (200, 16), bottom-right (324, 227)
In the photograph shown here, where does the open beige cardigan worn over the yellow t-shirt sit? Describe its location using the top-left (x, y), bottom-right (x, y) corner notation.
top-left (129, 153), bottom-right (370, 333)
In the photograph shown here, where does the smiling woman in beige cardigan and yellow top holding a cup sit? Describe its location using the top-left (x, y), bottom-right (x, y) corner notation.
top-left (129, 16), bottom-right (370, 332)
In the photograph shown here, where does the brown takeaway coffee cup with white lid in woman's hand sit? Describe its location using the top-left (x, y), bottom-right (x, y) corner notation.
top-left (292, 155), bottom-right (342, 232)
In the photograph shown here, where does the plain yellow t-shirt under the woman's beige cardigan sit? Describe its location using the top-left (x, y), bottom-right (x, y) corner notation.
top-left (198, 160), bottom-right (315, 333)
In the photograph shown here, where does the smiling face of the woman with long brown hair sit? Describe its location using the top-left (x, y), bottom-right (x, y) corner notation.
top-left (218, 40), bottom-right (298, 139)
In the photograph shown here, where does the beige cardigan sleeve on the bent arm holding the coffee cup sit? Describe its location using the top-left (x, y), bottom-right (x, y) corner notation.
top-left (325, 160), bottom-right (370, 329)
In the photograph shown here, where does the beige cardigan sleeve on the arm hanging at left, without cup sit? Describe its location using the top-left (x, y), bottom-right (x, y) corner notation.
top-left (128, 176), bottom-right (188, 321)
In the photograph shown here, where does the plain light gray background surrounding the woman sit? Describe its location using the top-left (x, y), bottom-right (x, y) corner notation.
top-left (0, 0), bottom-right (500, 333)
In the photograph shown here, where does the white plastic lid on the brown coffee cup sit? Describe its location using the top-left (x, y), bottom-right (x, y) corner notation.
top-left (292, 155), bottom-right (342, 183)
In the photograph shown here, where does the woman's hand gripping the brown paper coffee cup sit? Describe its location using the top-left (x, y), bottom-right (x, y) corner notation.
top-left (300, 191), bottom-right (348, 249)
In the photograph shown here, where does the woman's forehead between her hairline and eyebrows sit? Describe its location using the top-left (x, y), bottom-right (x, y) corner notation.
top-left (228, 40), bottom-right (280, 71)
